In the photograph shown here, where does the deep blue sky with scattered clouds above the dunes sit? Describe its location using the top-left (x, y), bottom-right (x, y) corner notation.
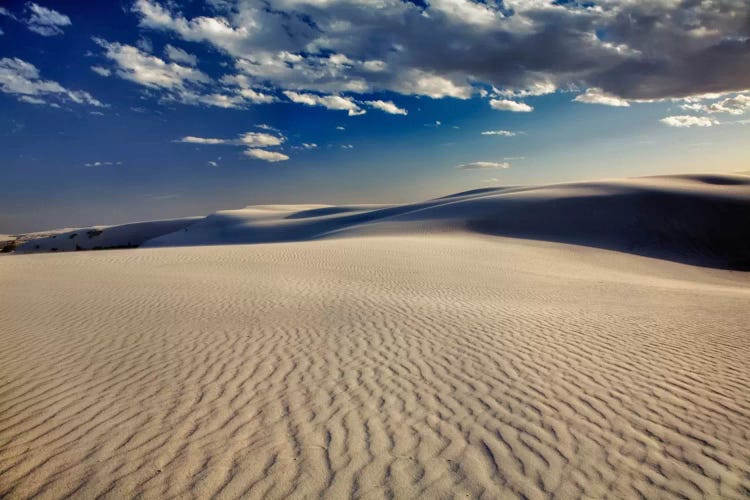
top-left (0, 0), bottom-right (750, 233)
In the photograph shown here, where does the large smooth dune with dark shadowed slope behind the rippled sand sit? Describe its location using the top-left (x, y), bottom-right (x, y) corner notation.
top-left (144, 175), bottom-right (750, 270)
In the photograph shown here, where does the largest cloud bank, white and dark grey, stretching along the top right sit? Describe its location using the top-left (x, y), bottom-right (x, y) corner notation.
top-left (133, 0), bottom-right (750, 109)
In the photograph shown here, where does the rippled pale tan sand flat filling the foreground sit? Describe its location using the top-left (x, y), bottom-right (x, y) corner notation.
top-left (0, 234), bottom-right (750, 499)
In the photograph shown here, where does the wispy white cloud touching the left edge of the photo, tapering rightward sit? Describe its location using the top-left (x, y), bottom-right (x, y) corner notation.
top-left (0, 57), bottom-right (106, 107)
